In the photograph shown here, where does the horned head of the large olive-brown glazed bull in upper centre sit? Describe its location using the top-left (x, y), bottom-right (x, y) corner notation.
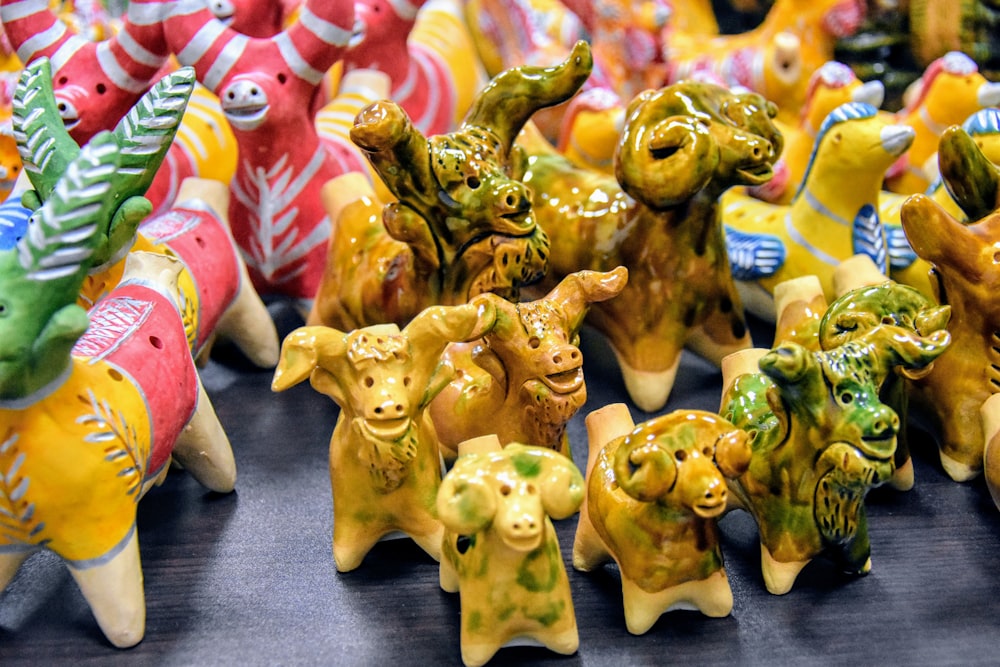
top-left (351, 42), bottom-right (592, 301)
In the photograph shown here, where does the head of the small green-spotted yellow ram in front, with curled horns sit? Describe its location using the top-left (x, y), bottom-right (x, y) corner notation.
top-left (437, 443), bottom-right (584, 553)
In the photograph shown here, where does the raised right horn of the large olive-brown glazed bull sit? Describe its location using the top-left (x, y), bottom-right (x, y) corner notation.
top-left (462, 41), bottom-right (594, 150)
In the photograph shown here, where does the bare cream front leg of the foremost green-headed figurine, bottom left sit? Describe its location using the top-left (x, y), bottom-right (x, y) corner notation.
top-left (69, 529), bottom-right (146, 648)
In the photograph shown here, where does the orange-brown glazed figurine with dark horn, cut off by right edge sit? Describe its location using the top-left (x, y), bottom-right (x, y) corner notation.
top-left (902, 127), bottom-right (1000, 490)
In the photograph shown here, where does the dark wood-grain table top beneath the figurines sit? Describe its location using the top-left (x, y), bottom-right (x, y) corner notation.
top-left (0, 304), bottom-right (1000, 666)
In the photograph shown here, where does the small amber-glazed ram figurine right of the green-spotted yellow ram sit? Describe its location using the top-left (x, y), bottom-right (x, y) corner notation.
top-left (573, 403), bottom-right (750, 635)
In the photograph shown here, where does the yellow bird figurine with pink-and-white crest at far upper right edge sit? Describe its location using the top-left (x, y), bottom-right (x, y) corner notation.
top-left (885, 51), bottom-right (1000, 194)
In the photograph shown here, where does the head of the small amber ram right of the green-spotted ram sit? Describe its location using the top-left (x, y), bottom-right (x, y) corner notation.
top-left (607, 410), bottom-right (750, 519)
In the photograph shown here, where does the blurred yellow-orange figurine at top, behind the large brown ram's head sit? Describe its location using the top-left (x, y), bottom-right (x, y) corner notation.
top-left (663, 0), bottom-right (864, 124)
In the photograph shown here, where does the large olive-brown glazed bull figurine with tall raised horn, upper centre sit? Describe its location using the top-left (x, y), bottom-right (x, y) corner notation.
top-left (308, 42), bottom-right (592, 329)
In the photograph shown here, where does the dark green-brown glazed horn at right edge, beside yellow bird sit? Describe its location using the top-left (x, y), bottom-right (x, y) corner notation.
top-left (938, 125), bottom-right (1000, 220)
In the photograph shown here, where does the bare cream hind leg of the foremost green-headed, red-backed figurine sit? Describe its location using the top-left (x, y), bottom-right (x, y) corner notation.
top-left (173, 378), bottom-right (236, 493)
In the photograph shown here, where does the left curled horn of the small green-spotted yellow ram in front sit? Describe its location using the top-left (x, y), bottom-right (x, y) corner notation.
top-left (437, 468), bottom-right (497, 535)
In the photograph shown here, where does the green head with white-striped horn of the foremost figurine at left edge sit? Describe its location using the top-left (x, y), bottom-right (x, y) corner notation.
top-left (0, 133), bottom-right (119, 400)
